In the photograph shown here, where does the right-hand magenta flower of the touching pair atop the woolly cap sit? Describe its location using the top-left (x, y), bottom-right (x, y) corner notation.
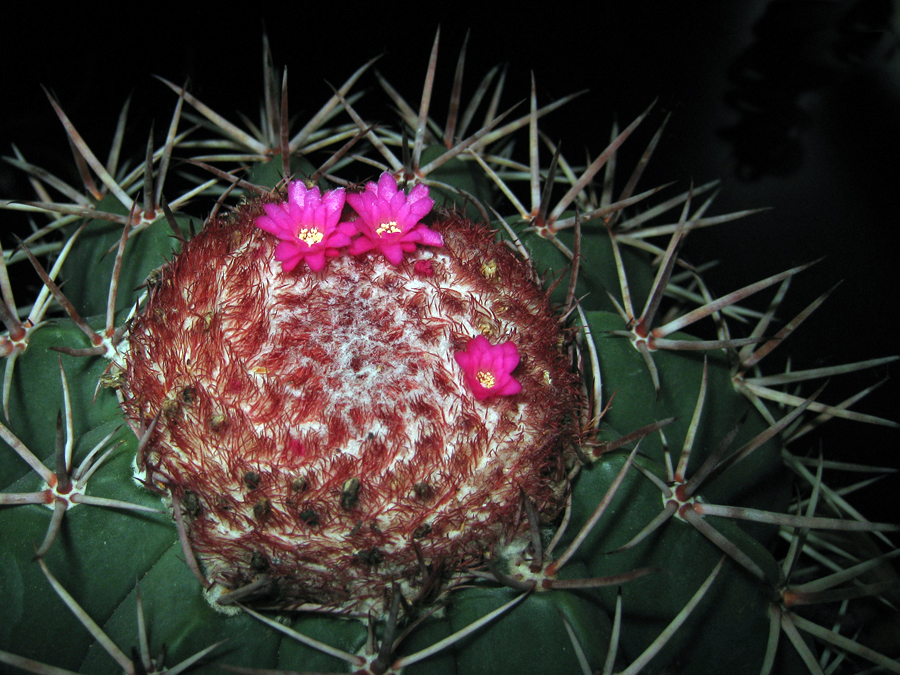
top-left (347, 171), bottom-right (444, 265)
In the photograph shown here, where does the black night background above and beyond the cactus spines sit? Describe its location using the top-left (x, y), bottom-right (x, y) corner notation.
top-left (0, 0), bottom-right (900, 520)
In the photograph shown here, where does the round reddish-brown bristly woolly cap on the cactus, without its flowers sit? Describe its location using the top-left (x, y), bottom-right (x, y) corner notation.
top-left (122, 193), bottom-right (581, 612)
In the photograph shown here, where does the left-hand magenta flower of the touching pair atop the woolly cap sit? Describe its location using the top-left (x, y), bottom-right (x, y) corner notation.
top-left (256, 180), bottom-right (356, 272)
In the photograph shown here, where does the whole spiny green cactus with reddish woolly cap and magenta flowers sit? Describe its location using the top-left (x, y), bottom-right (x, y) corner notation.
top-left (0, 31), bottom-right (900, 674)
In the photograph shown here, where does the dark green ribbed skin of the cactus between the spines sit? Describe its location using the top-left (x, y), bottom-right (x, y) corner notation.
top-left (0, 46), bottom-right (888, 675)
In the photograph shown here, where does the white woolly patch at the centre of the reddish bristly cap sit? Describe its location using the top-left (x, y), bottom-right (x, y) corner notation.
top-left (217, 252), bottom-right (524, 462)
